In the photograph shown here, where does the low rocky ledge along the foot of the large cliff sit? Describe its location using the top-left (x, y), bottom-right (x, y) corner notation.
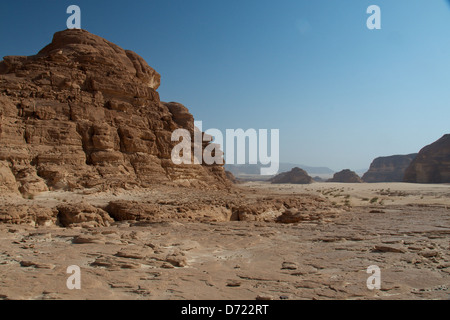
top-left (0, 185), bottom-right (343, 229)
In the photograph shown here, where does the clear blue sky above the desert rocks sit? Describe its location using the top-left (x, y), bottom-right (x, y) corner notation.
top-left (0, 0), bottom-right (450, 170)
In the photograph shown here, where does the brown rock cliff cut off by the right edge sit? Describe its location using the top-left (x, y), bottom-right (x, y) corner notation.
top-left (403, 134), bottom-right (450, 183)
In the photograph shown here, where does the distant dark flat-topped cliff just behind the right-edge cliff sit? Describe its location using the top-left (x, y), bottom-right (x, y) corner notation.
top-left (362, 153), bottom-right (417, 183)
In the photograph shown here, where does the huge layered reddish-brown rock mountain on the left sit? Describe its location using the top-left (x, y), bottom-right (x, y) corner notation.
top-left (0, 30), bottom-right (229, 194)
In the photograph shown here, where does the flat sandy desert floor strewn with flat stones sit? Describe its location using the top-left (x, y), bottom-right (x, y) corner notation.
top-left (0, 182), bottom-right (450, 300)
